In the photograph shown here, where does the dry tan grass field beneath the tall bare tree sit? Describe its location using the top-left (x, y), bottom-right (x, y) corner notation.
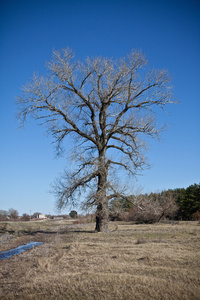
top-left (0, 221), bottom-right (200, 300)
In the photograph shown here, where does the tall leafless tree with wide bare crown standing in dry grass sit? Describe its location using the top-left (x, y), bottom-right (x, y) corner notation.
top-left (18, 49), bottom-right (173, 231)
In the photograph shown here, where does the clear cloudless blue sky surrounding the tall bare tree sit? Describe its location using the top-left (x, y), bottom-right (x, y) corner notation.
top-left (0, 0), bottom-right (200, 214)
